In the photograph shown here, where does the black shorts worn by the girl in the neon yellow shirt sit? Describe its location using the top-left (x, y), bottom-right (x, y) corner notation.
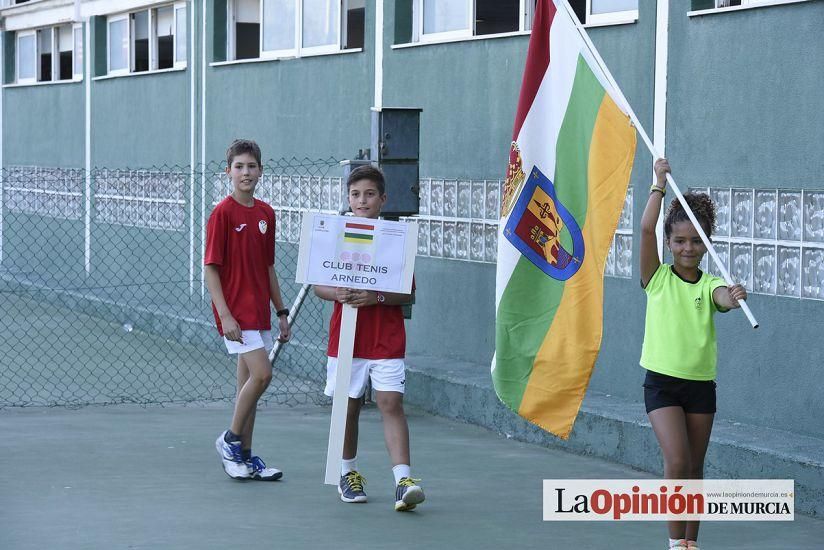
top-left (644, 370), bottom-right (715, 414)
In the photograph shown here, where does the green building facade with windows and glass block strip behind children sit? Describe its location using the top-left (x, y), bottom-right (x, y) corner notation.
top-left (0, 0), bottom-right (824, 444)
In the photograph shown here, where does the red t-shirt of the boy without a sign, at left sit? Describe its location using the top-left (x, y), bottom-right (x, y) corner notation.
top-left (203, 195), bottom-right (275, 336)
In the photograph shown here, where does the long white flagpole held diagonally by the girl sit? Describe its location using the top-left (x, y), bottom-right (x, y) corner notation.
top-left (550, 0), bottom-right (758, 328)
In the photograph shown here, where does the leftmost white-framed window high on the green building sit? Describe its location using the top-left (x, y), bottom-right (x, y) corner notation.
top-left (15, 24), bottom-right (83, 84)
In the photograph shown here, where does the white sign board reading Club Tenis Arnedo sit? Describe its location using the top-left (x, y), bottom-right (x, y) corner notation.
top-left (296, 212), bottom-right (418, 294)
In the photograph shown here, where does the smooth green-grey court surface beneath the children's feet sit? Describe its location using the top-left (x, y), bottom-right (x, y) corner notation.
top-left (0, 403), bottom-right (824, 550)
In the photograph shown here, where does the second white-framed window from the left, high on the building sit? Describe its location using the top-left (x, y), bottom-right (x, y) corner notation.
top-left (107, 3), bottom-right (187, 75)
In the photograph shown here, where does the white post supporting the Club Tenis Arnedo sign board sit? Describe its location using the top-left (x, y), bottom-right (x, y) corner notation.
top-left (323, 304), bottom-right (358, 485)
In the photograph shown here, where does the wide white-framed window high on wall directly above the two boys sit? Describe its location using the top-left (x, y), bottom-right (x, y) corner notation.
top-left (226, 0), bottom-right (366, 60)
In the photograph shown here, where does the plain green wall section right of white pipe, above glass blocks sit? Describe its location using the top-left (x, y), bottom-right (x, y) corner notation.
top-left (667, 1), bottom-right (824, 188)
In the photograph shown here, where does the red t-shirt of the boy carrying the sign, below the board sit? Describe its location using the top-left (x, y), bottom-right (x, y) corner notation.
top-left (326, 280), bottom-right (415, 359)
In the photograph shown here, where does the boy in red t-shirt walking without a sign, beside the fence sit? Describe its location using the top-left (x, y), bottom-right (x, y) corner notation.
top-left (203, 139), bottom-right (290, 481)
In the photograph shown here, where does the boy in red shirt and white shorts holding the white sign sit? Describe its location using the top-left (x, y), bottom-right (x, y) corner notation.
top-left (314, 166), bottom-right (424, 512)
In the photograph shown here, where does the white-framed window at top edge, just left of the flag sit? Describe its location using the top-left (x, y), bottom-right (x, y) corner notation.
top-left (412, 0), bottom-right (535, 42)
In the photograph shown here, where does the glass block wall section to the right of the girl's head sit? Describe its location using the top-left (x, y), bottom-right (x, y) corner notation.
top-left (693, 188), bottom-right (824, 300)
